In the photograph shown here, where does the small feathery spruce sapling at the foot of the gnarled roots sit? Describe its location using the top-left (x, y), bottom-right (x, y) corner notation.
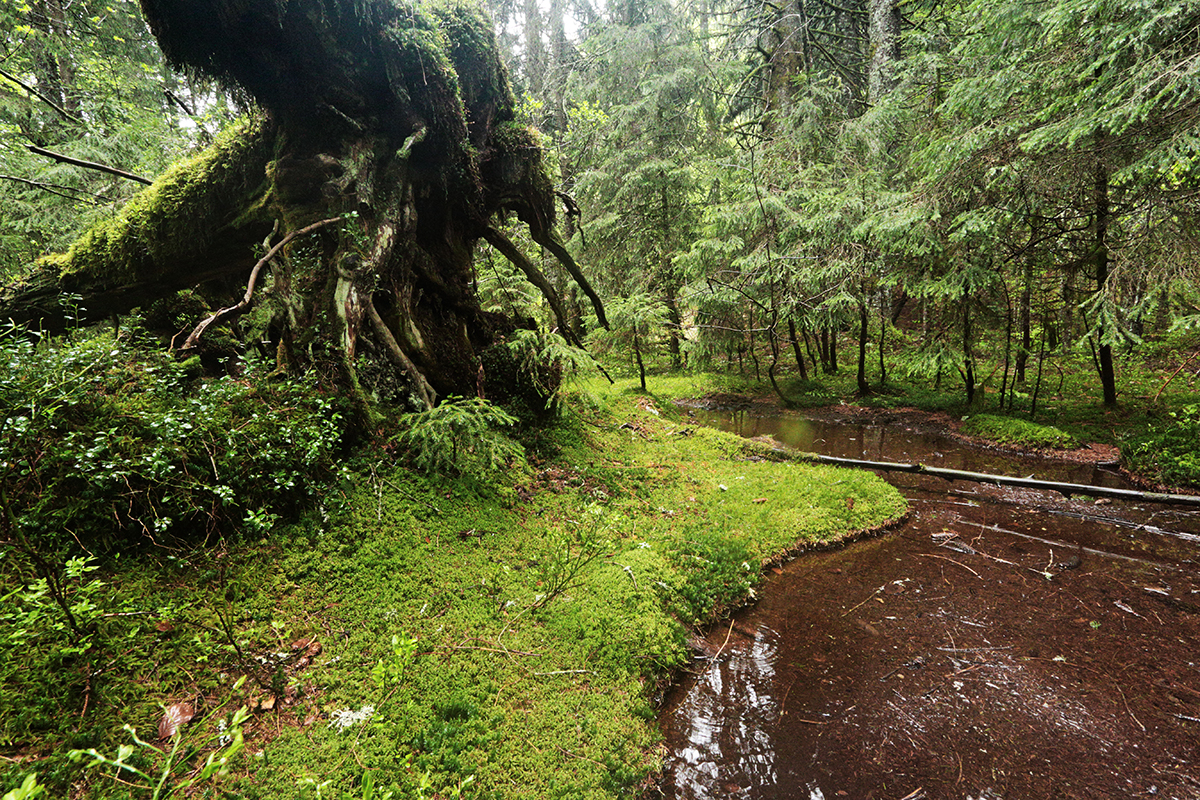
top-left (392, 397), bottom-right (524, 476)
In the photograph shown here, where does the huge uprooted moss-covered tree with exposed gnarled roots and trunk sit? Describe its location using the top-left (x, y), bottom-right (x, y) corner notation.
top-left (0, 0), bottom-right (604, 412)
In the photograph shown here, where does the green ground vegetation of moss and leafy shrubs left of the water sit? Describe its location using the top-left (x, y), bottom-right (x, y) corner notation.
top-left (0, 331), bottom-right (904, 800)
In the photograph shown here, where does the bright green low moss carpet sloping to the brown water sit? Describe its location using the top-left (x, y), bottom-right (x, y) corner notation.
top-left (0, 371), bottom-right (905, 799)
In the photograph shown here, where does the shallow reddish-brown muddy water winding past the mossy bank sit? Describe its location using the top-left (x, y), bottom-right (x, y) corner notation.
top-left (661, 411), bottom-right (1200, 800)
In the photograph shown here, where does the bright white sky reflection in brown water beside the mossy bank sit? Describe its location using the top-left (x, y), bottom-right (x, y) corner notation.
top-left (668, 626), bottom-right (779, 800)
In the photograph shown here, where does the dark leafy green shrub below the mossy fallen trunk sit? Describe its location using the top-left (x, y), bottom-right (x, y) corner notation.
top-left (0, 319), bottom-right (342, 549)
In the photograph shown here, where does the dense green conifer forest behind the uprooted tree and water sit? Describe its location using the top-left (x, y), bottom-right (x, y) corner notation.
top-left (0, 0), bottom-right (1200, 405)
